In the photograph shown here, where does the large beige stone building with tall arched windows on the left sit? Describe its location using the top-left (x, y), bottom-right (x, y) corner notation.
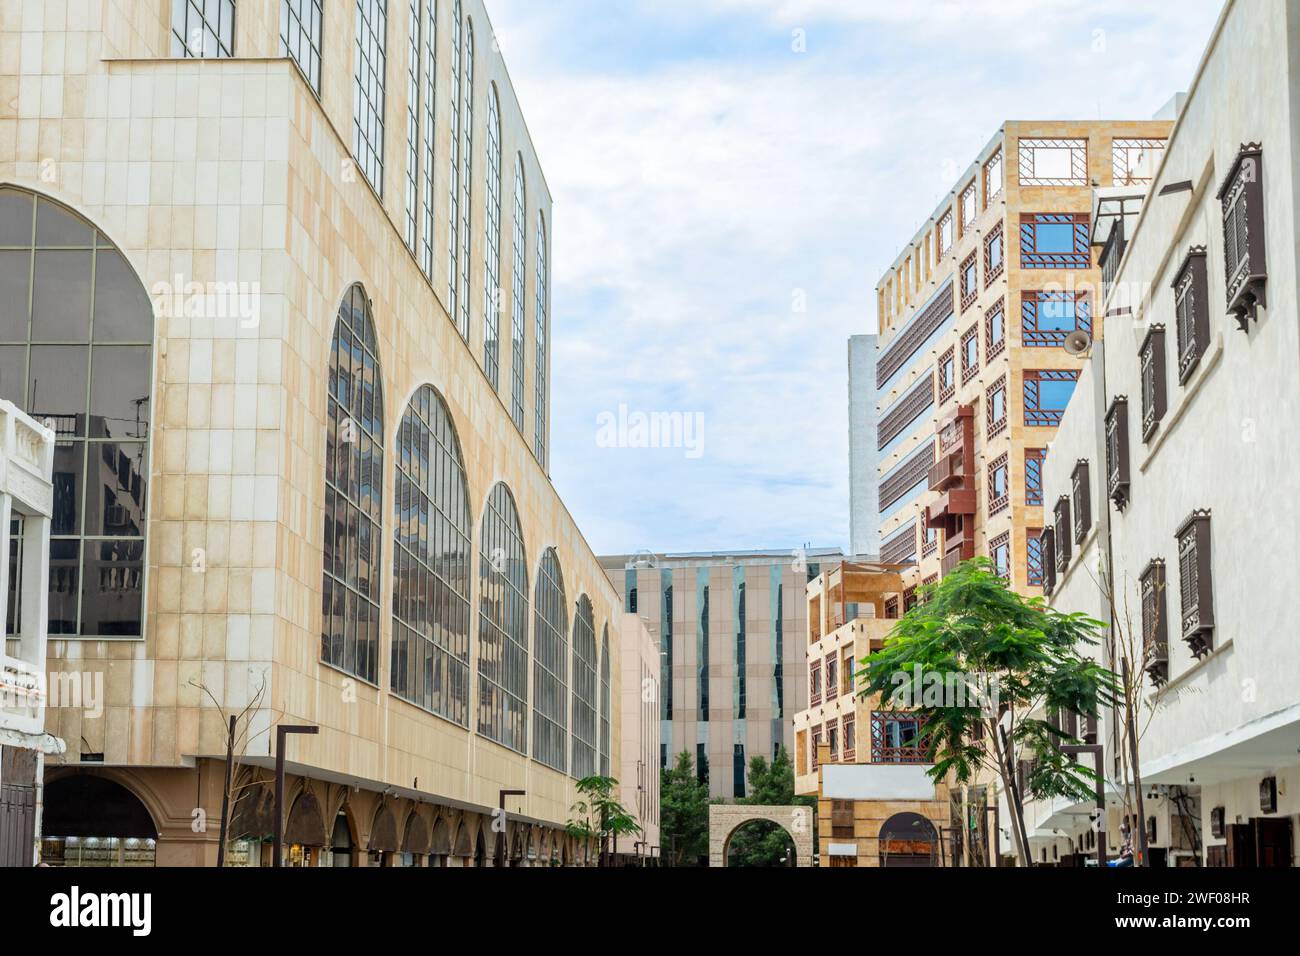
top-left (0, 0), bottom-right (621, 865)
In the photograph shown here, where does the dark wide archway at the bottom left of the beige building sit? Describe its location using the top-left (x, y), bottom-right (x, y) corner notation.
top-left (40, 774), bottom-right (159, 866)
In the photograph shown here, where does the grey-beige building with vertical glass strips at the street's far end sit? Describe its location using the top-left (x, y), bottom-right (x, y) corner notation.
top-left (601, 549), bottom-right (840, 800)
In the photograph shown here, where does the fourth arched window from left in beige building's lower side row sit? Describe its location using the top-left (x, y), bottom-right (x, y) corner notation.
top-left (533, 548), bottom-right (568, 773)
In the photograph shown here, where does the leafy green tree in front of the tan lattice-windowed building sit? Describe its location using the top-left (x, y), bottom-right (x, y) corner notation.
top-left (859, 558), bottom-right (1118, 866)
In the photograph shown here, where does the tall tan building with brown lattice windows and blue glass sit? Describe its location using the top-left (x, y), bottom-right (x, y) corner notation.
top-left (852, 120), bottom-right (1170, 593)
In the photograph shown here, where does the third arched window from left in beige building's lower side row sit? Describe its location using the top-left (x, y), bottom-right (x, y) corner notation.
top-left (478, 484), bottom-right (528, 753)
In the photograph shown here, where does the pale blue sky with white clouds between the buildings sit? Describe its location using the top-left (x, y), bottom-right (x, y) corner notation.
top-left (488, 0), bottom-right (1221, 554)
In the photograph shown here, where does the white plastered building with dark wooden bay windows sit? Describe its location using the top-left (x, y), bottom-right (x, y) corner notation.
top-left (1031, 0), bottom-right (1300, 868)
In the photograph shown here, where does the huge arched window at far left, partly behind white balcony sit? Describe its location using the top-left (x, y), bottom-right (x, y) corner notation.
top-left (0, 189), bottom-right (153, 637)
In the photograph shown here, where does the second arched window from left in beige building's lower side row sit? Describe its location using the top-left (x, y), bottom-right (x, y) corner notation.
top-left (389, 385), bottom-right (471, 727)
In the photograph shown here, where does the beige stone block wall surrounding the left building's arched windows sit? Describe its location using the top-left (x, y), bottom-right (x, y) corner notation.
top-left (0, 0), bottom-right (620, 819)
